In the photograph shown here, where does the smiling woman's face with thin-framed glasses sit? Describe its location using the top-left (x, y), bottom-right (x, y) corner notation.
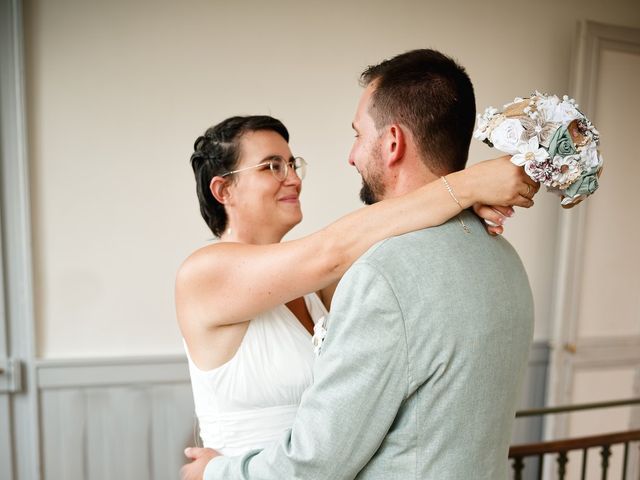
top-left (227, 130), bottom-right (302, 242)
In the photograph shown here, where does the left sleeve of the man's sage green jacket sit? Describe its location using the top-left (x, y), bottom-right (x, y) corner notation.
top-left (204, 262), bottom-right (409, 480)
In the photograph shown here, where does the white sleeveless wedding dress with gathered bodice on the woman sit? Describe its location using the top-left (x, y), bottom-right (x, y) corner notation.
top-left (185, 293), bottom-right (327, 455)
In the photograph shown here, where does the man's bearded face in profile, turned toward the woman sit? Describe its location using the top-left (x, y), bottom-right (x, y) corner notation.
top-left (349, 84), bottom-right (385, 205)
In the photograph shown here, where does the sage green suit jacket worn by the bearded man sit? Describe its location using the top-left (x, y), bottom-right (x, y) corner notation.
top-left (204, 212), bottom-right (533, 480)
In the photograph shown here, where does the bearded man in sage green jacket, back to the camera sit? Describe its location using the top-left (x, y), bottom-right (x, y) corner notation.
top-left (182, 50), bottom-right (533, 480)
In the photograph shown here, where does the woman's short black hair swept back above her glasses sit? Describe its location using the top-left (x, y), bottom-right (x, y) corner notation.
top-left (191, 115), bottom-right (289, 237)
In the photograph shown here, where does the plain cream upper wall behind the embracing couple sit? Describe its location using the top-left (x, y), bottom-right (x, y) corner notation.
top-left (25, 0), bottom-right (640, 358)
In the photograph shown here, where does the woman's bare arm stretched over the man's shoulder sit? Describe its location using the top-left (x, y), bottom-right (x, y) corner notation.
top-left (176, 157), bottom-right (532, 331)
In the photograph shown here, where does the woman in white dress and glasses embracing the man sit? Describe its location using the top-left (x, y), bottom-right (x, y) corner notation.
top-left (176, 116), bottom-right (536, 455)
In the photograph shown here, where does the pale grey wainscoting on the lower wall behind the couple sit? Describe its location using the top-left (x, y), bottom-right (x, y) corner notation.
top-left (36, 344), bottom-right (548, 480)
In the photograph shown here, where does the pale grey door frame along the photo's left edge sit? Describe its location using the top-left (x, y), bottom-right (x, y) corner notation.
top-left (0, 0), bottom-right (41, 480)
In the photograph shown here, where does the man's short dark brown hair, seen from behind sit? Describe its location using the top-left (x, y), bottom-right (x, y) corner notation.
top-left (360, 49), bottom-right (476, 175)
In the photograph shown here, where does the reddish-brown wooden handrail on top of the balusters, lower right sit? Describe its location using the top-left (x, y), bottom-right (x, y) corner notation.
top-left (509, 430), bottom-right (640, 458)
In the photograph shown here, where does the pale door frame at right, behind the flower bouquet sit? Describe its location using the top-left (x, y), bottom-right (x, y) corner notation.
top-left (545, 21), bottom-right (640, 439)
